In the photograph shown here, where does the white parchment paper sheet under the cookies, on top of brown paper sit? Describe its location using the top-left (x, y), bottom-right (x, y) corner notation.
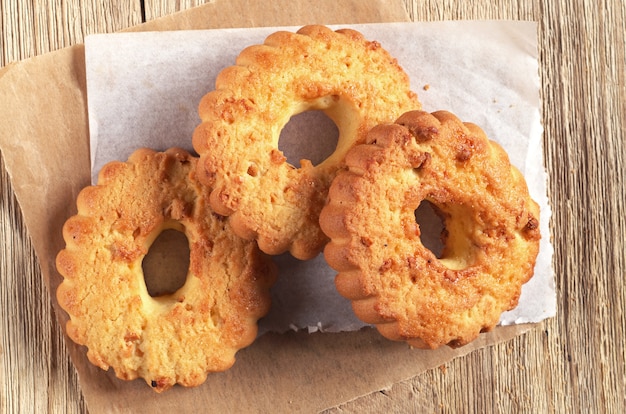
top-left (85, 21), bottom-right (556, 332)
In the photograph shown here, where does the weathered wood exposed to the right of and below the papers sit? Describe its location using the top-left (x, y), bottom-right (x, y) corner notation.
top-left (342, 1), bottom-right (626, 412)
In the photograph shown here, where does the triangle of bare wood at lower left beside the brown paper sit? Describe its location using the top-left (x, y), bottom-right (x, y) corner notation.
top-left (0, 154), bottom-right (85, 413)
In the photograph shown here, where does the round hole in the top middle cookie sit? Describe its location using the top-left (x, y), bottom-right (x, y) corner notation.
top-left (278, 110), bottom-right (339, 165)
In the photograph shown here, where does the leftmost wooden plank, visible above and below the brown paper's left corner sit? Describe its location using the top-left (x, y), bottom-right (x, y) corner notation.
top-left (0, 0), bottom-right (141, 413)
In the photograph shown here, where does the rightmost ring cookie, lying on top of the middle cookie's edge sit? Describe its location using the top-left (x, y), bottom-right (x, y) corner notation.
top-left (320, 111), bottom-right (540, 348)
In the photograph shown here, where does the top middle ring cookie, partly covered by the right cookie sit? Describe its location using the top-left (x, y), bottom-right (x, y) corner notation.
top-left (193, 26), bottom-right (420, 259)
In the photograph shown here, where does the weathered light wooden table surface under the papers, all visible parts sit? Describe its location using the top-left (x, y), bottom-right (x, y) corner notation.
top-left (0, 0), bottom-right (626, 413)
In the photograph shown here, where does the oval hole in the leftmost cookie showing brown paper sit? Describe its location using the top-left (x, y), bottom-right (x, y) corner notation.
top-left (141, 229), bottom-right (190, 298)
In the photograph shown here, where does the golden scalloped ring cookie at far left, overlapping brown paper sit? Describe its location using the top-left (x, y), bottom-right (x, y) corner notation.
top-left (57, 149), bottom-right (275, 392)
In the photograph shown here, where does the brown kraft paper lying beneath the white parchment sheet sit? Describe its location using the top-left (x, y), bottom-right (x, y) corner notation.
top-left (0, 0), bottom-right (532, 413)
